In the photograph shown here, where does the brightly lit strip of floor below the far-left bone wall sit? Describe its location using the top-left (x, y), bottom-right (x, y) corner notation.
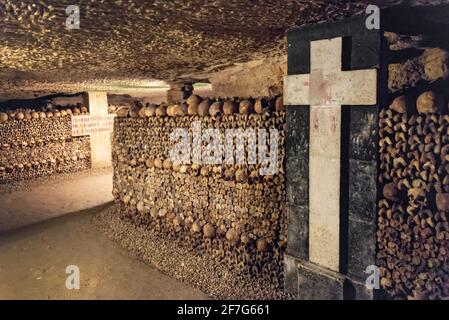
top-left (0, 169), bottom-right (113, 234)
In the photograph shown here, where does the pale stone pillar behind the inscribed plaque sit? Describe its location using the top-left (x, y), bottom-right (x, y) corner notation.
top-left (84, 92), bottom-right (112, 168)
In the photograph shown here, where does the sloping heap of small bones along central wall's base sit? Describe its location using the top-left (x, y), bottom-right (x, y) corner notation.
top-left (94, 207), bottom-right (292, 300)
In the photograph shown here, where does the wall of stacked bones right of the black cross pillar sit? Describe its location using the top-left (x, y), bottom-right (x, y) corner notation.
top-left (377, 34), bottom-right (449, 299)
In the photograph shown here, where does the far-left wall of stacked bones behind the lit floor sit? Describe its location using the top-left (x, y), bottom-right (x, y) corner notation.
top-left (0, 105), bottom-right (90, 184)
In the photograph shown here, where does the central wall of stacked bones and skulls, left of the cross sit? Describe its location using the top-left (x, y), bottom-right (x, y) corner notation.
top-left (113, 96), bottom-right (286, 287)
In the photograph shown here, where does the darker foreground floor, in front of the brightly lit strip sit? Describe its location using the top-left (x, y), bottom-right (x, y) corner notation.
top-left (0, 205), bottom-right (208, 300)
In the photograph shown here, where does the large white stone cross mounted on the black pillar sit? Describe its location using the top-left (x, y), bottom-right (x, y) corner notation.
top-left (284, 38), bottom-right (377, 272)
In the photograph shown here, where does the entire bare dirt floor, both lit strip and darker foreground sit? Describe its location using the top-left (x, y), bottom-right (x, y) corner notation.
top-left (0, 172), bottom-right (208, 300)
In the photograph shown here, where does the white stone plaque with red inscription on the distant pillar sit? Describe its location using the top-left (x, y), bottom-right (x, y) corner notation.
top-left (72, 114), bottom-right (115, 137)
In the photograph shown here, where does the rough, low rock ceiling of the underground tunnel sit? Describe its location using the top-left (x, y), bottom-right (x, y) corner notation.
top-left (0, 0), bottom-right (441, 96)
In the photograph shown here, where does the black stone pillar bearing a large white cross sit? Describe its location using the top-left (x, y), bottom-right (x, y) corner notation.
top-left (284, 17), bottom-right (383, 299)
